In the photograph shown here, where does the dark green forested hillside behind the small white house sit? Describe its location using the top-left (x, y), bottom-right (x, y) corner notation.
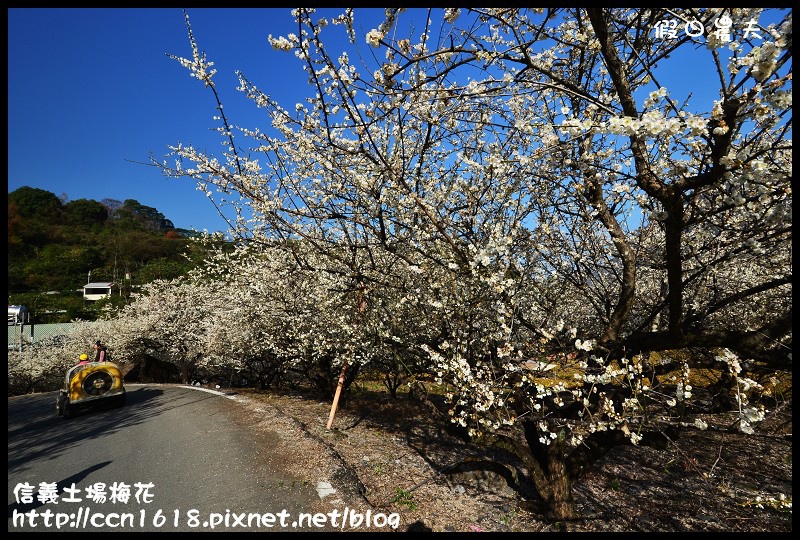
top-left (7, 186), bottom-right (222, 322)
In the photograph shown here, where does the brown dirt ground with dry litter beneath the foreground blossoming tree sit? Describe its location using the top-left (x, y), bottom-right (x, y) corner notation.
top-left (228, 390), bottom-right (792, 532)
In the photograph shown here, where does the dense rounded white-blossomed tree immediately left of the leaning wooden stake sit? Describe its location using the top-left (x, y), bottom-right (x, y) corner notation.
top-left (193, 238), bottom-right (364, 390)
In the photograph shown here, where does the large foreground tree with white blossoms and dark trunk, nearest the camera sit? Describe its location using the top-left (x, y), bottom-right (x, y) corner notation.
top-left (153, 8), bottom-right (792, 518)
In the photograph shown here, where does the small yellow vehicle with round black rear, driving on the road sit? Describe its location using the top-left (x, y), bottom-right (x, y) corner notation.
top-left (56, 362), bottom-right (127, 418)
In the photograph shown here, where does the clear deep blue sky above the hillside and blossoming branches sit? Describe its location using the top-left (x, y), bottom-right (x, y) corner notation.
top-left (8, 8), bottom-right (792, 231)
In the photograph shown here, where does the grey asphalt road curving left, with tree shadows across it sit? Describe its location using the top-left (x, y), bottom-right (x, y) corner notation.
top-left (8, 385), bottom-right (328, 532)
